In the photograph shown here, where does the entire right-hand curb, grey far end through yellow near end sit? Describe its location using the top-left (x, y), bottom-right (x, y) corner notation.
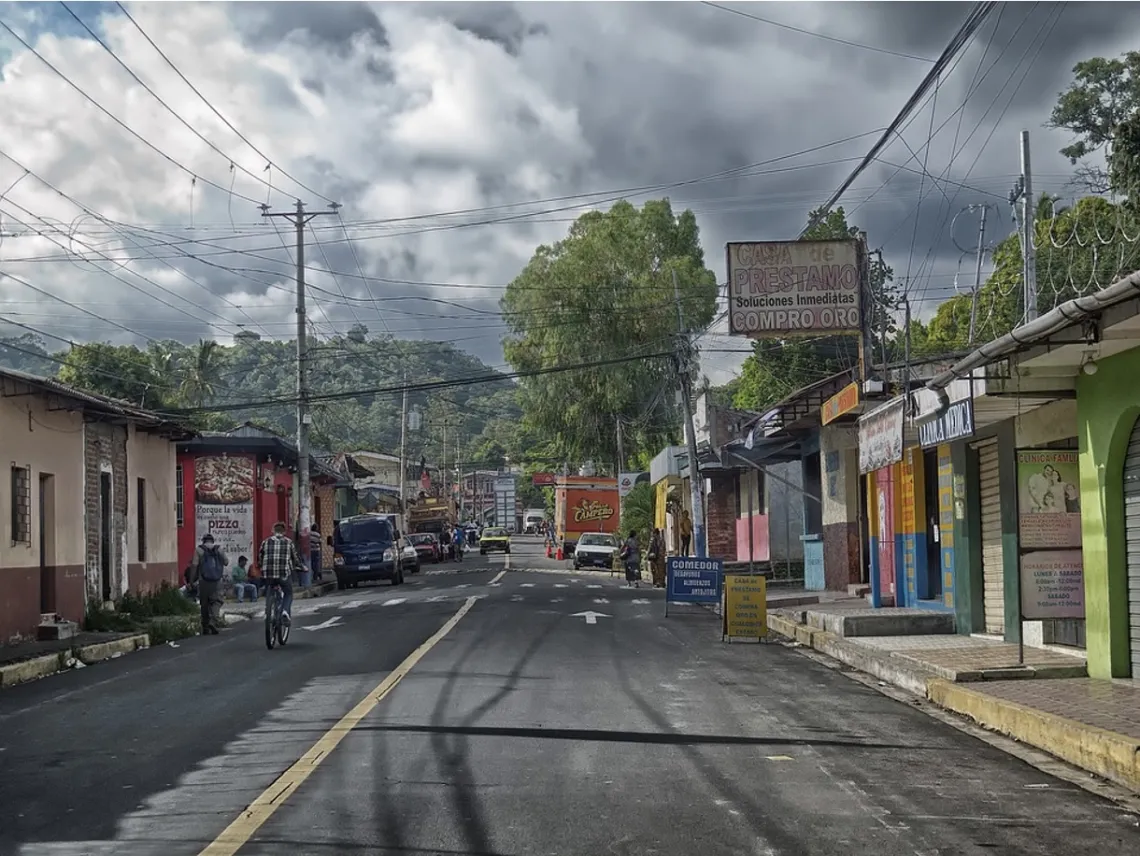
top-left (768, 614), bottom-right (1140, 793)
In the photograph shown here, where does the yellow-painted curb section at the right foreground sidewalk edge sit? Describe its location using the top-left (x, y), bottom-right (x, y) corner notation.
top-left (927, 678), bottom-right (1140, 793)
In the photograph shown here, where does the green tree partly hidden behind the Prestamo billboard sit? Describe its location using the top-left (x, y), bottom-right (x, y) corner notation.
top-left (732, 207), bottom-right (899, 410)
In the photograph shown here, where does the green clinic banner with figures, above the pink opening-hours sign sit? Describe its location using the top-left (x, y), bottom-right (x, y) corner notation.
top-left (1017, 449), bottom-right (1081, 551)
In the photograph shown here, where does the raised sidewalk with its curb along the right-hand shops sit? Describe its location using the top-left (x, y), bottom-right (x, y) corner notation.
top-left (768, 602), bottom-right (1140, 793)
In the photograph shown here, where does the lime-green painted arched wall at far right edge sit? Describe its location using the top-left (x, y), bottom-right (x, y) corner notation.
top-left (1076, 349), bottom-right (1140, 678)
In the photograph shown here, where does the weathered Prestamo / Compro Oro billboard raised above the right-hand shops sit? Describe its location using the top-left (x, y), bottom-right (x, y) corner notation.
top-left (726, 241), bottom-right (861, 339)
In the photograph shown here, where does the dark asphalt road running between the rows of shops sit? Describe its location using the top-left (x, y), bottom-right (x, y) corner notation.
top-left (0, 538), bottom-right (1140, 856)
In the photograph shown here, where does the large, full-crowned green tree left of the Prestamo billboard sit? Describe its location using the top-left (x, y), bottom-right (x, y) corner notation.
top-left (502, 199), bottom-right (717, 464)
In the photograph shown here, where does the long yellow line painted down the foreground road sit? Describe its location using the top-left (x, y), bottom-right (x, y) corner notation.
top-left (198, 597), bottom-right (478, 856)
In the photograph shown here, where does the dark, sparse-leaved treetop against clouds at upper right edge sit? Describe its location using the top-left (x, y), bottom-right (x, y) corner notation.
top-left (1048, 50), bottom-right (1140, 193)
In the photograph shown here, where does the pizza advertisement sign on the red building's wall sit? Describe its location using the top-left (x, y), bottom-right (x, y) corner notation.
top-left (194, 456), bottom-right (257, 566)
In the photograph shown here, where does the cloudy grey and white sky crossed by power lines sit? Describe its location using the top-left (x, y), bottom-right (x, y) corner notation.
top-left (0, 2), bottom-right (1140, 382)
